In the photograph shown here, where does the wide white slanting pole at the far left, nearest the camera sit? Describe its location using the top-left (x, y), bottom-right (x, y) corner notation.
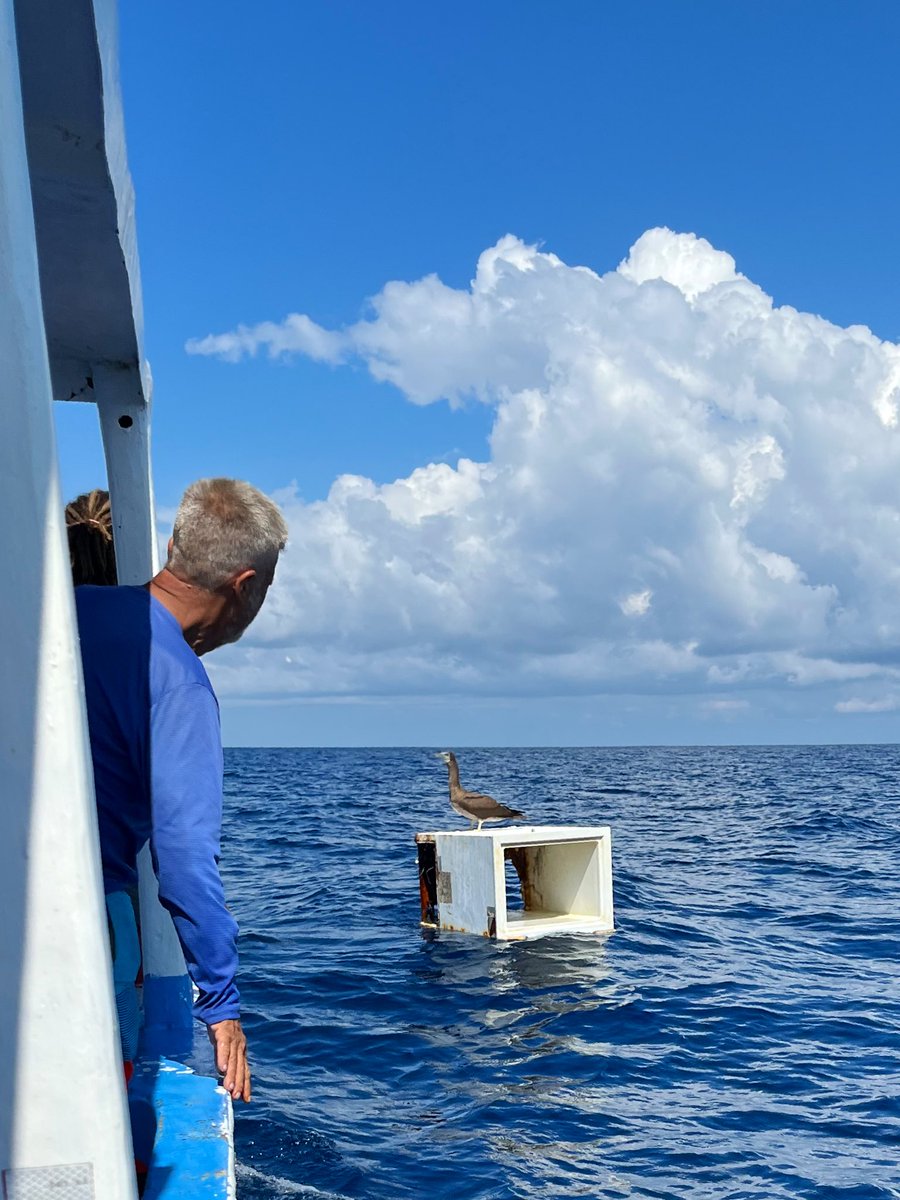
top-left (0, 0), bottom-right (136, 1185)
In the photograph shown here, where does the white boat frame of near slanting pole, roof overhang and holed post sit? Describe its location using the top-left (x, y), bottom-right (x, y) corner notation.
top-left (0, 0), bottom-right (216, 1200)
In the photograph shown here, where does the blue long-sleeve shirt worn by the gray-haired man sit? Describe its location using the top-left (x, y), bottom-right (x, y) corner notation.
top-left (76, 587), bottom-right (240, 1025)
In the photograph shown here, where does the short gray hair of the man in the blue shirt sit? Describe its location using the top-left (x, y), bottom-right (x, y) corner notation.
top-left (166, 479), bottom-right (288, 600)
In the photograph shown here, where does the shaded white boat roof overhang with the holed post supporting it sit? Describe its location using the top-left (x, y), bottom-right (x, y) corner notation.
top-left (13, 0), bottom-right (191, 1050)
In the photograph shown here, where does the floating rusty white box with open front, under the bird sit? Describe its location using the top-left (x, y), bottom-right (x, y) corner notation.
top-left (415, 826), bottom-right (614, 941)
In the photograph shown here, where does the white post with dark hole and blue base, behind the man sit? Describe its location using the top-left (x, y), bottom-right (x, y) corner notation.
top-left (94, 367), bottom-right (193, 1054)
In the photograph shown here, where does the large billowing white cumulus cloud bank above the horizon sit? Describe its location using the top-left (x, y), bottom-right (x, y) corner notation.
top-left (188, 229), bottom-right (900, 710)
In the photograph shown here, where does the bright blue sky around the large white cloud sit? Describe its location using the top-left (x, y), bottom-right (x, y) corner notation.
top-left (59, 0), bottom-right (900, 744)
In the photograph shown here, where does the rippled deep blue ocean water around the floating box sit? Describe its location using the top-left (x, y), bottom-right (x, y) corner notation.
top-left (222, 746), bottom-right (900, 1200)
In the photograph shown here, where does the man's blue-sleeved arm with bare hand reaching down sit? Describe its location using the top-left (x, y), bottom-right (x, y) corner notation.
top-left (150, 683), bottom-right (250, 1100)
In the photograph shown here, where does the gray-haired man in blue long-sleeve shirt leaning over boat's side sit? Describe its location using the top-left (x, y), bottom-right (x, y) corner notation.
top-left (76, 479), bottom-right (287, 1100)
